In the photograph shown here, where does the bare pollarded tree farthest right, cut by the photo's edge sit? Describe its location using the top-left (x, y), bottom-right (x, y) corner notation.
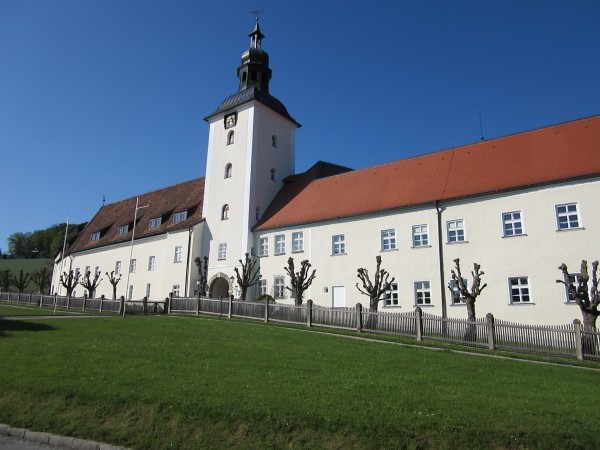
top-left (556, 260), bottom-right (600, 332)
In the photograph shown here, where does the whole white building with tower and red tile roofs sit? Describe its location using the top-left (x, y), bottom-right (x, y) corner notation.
top-left (53, 23), bottom-right (600, 324)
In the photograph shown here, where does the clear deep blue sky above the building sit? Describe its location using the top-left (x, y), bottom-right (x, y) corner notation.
top-left (0, 0), bottom-right (600, 252)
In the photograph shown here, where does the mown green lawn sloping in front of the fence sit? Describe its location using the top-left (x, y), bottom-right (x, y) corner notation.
top-left (0, 316), bottom-right (600, 449)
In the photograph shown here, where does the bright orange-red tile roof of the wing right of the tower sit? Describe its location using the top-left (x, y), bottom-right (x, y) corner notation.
top-left (256, 116), bottom-right (600, 230)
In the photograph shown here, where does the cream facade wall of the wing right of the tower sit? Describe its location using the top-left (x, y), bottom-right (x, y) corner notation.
top-left (255, 179), bottom-right (600, 324)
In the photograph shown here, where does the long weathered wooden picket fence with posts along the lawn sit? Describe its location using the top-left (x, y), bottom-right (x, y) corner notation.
top-left (0, 292), bottom-right (600, 361)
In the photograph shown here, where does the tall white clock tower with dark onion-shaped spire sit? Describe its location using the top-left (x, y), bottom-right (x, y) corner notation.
top-left (202, 18), bottom-right (300, 295)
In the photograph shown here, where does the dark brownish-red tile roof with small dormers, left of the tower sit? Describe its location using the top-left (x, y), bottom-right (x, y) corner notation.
top-left (69, 178), bottom-right (204, 252)
